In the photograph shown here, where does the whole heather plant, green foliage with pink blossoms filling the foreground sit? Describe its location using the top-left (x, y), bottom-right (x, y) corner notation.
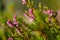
top-left (0, 0), bottom-right (60, 40)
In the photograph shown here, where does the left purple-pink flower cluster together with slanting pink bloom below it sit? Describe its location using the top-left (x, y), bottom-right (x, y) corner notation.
top-left (7, 14), bottom-right (20, 35)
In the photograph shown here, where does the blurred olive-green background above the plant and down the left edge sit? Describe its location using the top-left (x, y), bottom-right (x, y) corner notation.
top-left (0, 0), bottom-right (60, 40)
